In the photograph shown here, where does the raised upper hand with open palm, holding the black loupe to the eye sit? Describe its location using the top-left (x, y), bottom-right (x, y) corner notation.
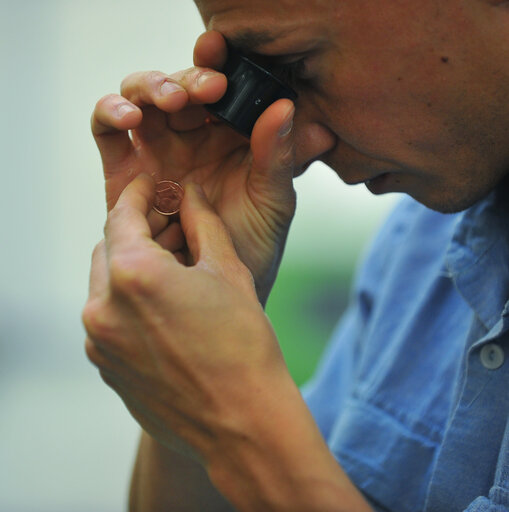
top-left (92, 32), bottom-right (295, 304)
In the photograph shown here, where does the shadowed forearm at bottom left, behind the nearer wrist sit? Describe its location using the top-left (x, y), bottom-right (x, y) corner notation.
top-left (129, 432), bottom-right (233, 512)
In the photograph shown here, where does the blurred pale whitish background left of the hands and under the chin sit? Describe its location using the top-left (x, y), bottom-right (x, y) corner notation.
top-left (0, 0), bottom-right (394, 512)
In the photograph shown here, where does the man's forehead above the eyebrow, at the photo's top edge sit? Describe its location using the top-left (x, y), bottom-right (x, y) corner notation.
top-left (195, 0), bottom-right (336, 50)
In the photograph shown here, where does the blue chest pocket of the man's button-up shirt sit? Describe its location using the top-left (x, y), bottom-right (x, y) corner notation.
top-left (328, 398), bottom-right (437, 512)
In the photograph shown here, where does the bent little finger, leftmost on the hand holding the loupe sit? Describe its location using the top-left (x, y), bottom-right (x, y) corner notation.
top-left (91, 94), bottom-right (142, 166)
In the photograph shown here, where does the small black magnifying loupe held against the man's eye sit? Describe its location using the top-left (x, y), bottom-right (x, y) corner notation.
top-left (205, 47), bottom-right (297, 138)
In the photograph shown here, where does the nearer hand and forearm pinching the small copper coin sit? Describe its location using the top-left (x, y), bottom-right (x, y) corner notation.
top-left (83, 176), bottom-right (370, 512)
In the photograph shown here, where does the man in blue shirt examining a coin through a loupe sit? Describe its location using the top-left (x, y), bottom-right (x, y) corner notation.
top-left (83, 0), bottom-right (509, 512)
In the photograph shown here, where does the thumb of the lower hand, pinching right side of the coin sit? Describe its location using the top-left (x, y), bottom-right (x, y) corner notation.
top-left (180, 183), bottom-right (238, 268)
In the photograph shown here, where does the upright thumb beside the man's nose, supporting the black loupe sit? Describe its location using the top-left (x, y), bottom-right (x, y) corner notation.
top-left (250, 99), bottom-right (295, 194)
